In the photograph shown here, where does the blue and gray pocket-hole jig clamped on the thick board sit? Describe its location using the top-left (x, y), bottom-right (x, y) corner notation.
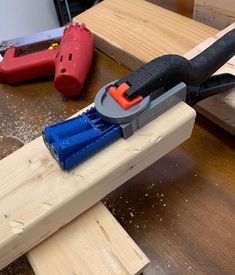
top-left (42, 82), bottom-right (186, 170)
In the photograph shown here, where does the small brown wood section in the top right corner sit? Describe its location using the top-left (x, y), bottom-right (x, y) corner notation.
top-left (193, 0), bottom-right (235, 30)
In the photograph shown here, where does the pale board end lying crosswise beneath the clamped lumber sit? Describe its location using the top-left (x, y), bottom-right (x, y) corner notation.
top-left (27, 203), bottom-right (149, 275)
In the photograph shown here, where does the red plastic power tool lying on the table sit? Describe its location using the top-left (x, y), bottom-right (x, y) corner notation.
top-left (0, 24), bottom-right (94, 96)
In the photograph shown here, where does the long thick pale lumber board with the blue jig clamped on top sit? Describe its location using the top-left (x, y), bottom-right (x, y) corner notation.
top-left (0, 102), bottom-right (195, 268)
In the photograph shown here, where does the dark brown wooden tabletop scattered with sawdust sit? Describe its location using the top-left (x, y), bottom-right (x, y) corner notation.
top-left (0, 0), bottom-right (235, 274)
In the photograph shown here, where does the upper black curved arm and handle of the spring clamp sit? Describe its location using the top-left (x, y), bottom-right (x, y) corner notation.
top-left (115, 29), bottom-right (235, 99)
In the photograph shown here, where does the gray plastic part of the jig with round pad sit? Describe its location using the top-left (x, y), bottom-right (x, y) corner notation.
top-left (95, 81), bottom-right (186, 139)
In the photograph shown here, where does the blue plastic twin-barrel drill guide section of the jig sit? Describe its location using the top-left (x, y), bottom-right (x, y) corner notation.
top-left (42, 107), bottom-right (122, 170)
